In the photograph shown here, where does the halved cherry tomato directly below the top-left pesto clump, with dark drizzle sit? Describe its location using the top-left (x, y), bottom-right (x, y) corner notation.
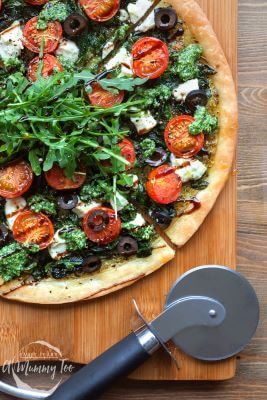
top-left (23, 17), bottom-right (62, 53)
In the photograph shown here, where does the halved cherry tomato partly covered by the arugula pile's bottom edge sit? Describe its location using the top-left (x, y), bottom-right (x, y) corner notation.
top-left (45, 164), bottom-right (86, 190)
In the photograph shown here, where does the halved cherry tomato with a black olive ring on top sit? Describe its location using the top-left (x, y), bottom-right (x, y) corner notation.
top-left (83, 207), bottom-right (121, 245)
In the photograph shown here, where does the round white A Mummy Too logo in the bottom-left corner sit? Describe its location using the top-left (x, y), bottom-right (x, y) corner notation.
top-left (2, 340), bottom-right (75, 395)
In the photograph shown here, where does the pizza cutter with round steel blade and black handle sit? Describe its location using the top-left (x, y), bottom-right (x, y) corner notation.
top-left (45, 265), bottom-right (259, 400)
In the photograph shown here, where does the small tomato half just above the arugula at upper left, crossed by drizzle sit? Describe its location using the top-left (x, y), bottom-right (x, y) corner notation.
top-left (28, 54), bottom-right (64, 82)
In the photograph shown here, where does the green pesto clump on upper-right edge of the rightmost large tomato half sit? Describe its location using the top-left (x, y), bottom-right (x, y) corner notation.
top-left (189, 107), bottom-right (218, 135)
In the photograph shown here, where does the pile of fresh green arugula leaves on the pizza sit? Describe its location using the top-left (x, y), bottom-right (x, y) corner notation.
top-left (0, 69), bottom-right (146, 177)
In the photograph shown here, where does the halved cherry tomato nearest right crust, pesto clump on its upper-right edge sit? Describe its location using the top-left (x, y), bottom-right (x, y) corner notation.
top-left (164, 115), bottom-right (204, 158)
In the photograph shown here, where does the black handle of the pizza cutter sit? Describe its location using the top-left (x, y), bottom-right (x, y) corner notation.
top-left (48, 333), bottom-right (149, 400)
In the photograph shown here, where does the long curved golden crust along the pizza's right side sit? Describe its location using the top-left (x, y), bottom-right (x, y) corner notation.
top-left (166, 0), bottom-right (238, 247)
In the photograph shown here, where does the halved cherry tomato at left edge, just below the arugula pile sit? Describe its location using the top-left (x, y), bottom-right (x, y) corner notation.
top-left (0, 160), bottom-right (33, 199)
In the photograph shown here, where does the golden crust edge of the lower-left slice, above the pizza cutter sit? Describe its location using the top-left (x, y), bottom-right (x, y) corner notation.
top-left (0, 239), bottom-right (175, 304)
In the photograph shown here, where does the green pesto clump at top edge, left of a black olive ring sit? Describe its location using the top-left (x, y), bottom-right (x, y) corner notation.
top-left (36, 0), bottom-right (68, 29)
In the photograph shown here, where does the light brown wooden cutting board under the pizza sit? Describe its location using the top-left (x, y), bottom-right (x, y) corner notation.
top-left (0, 0), bottom-right (237, 380)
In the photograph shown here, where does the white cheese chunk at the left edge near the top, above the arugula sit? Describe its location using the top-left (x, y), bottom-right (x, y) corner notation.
top-left (0, 21), bottom-right (23, 61)
